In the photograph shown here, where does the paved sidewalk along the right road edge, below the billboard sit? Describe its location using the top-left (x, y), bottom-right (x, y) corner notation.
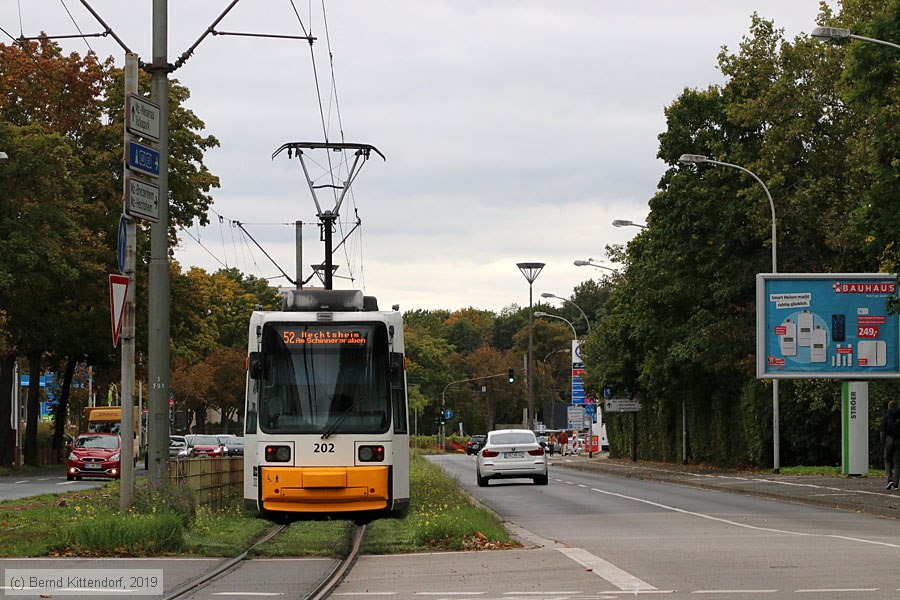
top-left (550, 452), bottom-right (900, 519)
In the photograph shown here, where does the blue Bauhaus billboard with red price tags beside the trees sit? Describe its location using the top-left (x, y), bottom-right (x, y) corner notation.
top-left (756, 273), bottom-right (900, 379)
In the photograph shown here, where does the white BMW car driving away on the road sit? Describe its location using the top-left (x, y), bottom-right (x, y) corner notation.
top-left (475, 429), bottom-right (547, 487)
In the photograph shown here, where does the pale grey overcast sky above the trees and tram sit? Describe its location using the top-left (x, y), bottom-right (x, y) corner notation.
top-left (0, 0), bottom-right (837, 311)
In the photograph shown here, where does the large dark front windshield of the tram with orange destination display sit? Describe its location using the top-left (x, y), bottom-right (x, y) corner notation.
top-left (259, 323), bottom-right (390, 435)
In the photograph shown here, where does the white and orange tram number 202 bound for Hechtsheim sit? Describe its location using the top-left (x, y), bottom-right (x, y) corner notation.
top-left (244, 289), bottom-right (409, 515)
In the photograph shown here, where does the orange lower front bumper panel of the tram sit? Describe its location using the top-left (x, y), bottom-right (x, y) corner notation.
top-left (259, 466), bottom-right (391, 513)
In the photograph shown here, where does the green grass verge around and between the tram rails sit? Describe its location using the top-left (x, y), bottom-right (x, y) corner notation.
top-left (0, 454), bottom-right (516, 558)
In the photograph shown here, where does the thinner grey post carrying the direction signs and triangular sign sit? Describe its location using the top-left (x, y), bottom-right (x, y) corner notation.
top-left (119, 53), bottom-right (138, 513)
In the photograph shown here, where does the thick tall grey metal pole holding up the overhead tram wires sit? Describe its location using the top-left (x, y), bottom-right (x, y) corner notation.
top-left (147, 0), bottom-right (170, 479)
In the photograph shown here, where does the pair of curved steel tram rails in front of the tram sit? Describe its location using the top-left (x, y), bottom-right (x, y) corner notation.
top-left (163, 523), bottom-right (366, 600)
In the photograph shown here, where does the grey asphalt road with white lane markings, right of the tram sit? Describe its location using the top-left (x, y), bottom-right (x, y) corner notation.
top-left (338, 456), bottom-right (900, 600)
